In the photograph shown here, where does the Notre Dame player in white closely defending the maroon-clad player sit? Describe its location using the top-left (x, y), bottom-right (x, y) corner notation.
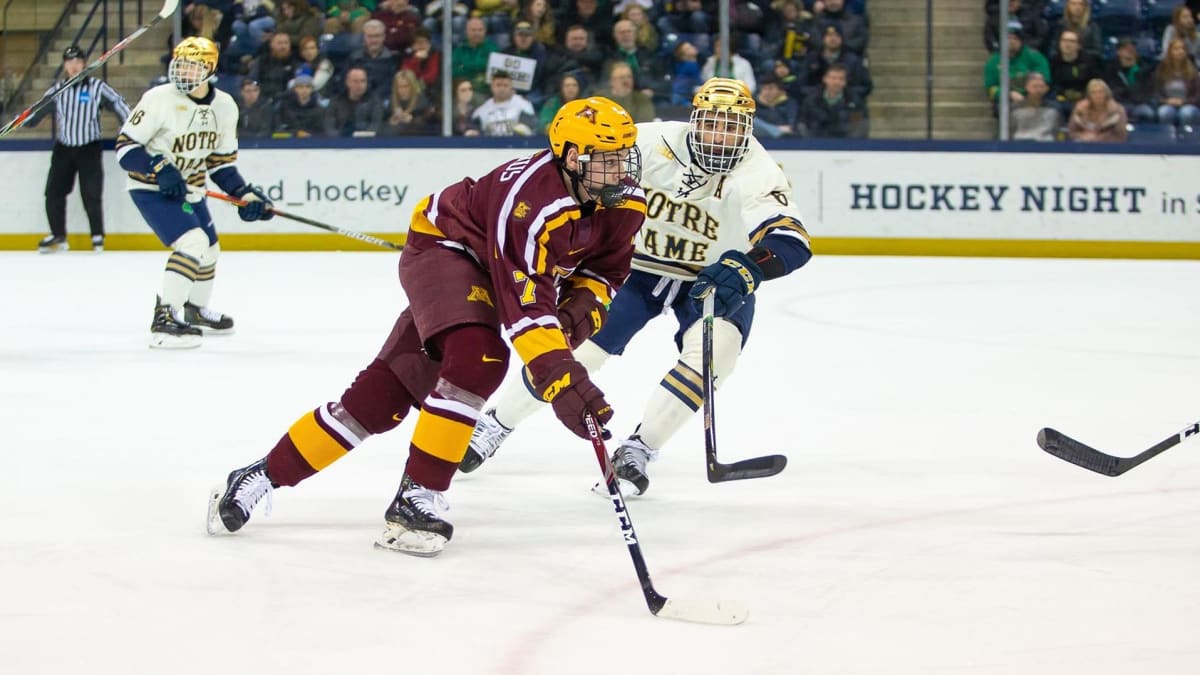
top-left (458, 78), bottom-right (812, 495)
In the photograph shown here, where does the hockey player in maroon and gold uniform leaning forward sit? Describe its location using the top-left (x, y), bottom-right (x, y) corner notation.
top-left (208, 97), bottom-right (646, 556)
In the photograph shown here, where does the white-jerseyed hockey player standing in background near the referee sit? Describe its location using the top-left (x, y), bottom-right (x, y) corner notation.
top-left (116, 37), bottom-right (274, 348)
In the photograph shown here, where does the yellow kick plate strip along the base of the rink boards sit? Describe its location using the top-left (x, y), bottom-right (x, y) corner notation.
top-left (0, 232), bottom-right (1200, 261)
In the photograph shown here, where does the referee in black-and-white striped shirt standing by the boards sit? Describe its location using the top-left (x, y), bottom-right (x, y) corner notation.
top-left (30, 44), bottom-right (130, 253)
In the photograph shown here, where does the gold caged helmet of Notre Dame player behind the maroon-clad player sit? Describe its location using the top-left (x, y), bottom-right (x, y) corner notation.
top-left (688, 77), bottom-right (756, 173)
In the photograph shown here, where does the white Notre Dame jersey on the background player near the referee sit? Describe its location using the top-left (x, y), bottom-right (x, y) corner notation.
top-left (116, 83), bottom-right (238, 202)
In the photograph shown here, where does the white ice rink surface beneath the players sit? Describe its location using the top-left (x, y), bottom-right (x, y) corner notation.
top-left (0, 252), bottom-right (1200, 675)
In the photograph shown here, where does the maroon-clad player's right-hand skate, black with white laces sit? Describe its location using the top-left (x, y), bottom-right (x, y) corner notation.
top-left (376, 473), bottom-right (454, 557)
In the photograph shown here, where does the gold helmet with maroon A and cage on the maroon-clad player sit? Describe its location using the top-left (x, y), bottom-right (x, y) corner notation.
top-left (547, 96), bottom-right (642, 209)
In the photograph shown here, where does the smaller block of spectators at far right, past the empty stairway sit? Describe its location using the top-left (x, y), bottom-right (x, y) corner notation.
top-left (983, 0), bottom-right (1200, 143)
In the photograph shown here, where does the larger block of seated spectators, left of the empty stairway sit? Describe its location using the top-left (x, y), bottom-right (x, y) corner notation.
top-left (175, 0), bottom-right (874, 138)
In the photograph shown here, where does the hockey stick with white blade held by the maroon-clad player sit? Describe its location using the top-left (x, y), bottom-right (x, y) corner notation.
top-left (583, 413), bottom-right (750, 626)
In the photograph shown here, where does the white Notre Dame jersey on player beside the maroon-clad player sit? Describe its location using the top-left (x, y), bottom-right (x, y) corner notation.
top-left (632, 121), bottom-right (811, 281)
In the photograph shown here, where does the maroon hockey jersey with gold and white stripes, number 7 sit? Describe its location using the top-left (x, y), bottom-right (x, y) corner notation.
top-left (410, 150), bottom-right (646, 381)
